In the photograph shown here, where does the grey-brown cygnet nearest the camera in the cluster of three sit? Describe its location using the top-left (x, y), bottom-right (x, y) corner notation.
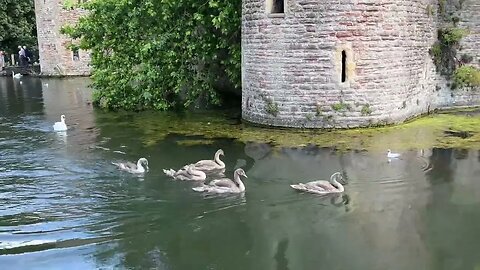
top-left (192, 168), bottom-right (248, 193)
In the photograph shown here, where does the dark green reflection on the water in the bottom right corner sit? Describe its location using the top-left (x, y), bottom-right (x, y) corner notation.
top-left (422, 149), bottom-right (480, 270)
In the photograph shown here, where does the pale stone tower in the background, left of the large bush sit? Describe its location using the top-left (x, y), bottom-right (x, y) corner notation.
top-left (35, 0), bottom-right (90, 75)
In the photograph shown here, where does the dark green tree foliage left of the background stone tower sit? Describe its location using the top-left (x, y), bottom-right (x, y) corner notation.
top-left (0, 0), bottom-right (37, 57)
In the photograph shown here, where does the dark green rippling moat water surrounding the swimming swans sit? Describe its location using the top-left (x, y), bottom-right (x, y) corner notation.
top-left (0, 78), bottom-right (480, 270)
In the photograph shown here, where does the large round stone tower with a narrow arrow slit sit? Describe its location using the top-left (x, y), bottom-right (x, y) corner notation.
top-left (242, 0), bottom-right (437, 128)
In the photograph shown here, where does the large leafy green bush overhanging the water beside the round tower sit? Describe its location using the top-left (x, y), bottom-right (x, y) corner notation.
top-left (62, 0), bottom-right (241, 110)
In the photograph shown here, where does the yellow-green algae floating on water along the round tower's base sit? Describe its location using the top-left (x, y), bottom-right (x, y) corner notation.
top-left (122, 112), bottom-right (480, 151)
